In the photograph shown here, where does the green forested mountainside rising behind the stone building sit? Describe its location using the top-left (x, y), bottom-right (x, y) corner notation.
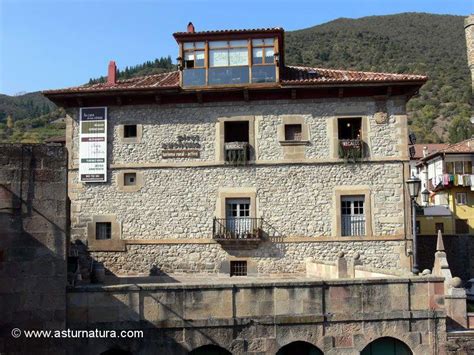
top-left (0, 13), bottom-right (474, 143)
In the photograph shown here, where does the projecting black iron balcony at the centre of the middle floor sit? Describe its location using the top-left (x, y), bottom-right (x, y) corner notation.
top-left (212, 217), bottom-right (265, 249)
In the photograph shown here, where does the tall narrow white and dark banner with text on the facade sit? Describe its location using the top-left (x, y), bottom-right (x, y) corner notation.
top-left (79, 107), bottom-right (107, 182)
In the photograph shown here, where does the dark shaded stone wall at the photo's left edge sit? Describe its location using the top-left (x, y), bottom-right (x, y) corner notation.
top-left (0, 144), bottom-right (68, 354)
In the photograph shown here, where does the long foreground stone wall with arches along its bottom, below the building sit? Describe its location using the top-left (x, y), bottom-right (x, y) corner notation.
top-left (67, 278), bottom-right (446, 355)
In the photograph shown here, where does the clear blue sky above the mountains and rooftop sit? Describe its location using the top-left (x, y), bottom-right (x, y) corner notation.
top-left (0, 0), bottom-right (474, 95)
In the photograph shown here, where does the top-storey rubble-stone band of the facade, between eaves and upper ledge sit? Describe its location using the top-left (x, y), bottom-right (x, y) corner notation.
top-left (68, 97), bottom-right (406, 166)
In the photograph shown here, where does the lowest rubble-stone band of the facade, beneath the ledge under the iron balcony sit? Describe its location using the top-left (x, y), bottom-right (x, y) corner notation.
top-left (91, 241), bottom-right (404, 275)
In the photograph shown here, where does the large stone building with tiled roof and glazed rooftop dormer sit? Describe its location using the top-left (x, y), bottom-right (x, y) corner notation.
top-left (44, 24), bottom-right (427, 275)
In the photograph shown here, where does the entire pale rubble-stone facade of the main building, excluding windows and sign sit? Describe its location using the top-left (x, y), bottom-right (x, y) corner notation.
top-left (67, 97), bottom-right (409, 274)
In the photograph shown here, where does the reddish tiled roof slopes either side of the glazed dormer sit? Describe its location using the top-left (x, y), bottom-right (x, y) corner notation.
top-left (43, 66), bottom-right (428, 94)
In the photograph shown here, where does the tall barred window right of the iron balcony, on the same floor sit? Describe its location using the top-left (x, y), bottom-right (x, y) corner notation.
top-left (341, 196), bottom-right (365, 236)
